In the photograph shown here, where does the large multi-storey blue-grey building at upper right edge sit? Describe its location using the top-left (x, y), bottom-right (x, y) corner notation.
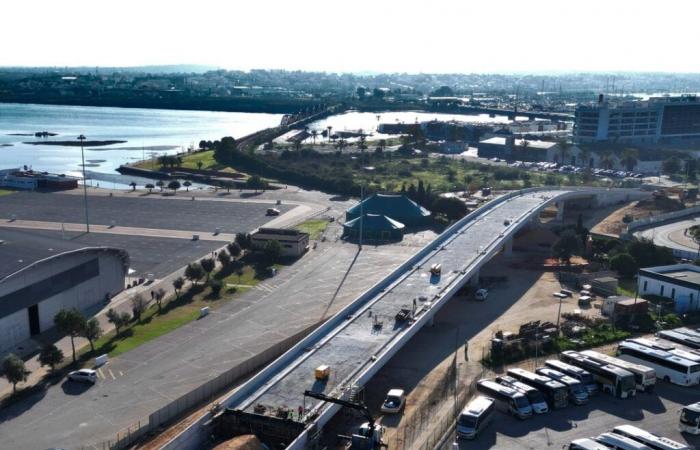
top-left (574, 95), bottom-right (700, 144)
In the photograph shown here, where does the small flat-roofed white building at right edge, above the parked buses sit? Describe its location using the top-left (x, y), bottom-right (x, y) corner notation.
top-left (637, 264), bottom-right (700, 312)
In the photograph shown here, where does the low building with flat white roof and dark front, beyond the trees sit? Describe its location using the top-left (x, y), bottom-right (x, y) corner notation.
top-left (478, 136), bottom-right (559, 162)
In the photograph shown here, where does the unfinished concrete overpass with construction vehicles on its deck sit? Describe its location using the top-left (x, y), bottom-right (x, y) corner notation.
top-left (164, 188), bottom-right (648, 450)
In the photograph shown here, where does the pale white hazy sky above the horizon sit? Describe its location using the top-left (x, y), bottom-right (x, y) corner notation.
top-left (0, 0), bottom-right (700, 72)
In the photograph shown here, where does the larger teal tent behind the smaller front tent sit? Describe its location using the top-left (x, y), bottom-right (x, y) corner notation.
top-left (345, 194), bottom-right (431, 227)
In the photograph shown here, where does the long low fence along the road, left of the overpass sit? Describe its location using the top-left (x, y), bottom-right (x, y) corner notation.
top-left (85, 323), bottom-right (319, 450)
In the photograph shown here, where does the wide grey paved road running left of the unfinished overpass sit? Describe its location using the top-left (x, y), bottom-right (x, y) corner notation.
top-left (0, 244), bottom-right (416, 450)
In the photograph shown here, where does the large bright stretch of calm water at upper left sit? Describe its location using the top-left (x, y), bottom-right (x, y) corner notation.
top-left (0, 103), bottom-right (282, 179)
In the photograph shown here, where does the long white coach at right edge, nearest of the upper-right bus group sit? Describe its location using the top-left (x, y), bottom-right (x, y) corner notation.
top-left (617, 341), bottom-right (700, 386)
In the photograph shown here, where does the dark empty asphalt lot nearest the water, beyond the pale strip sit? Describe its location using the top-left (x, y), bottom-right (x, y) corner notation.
top-left (0, 192), bottom-right (294, 233)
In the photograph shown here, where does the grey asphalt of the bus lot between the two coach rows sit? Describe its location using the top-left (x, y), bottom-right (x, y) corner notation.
top-left (443, 382), bottom-right (700, 450)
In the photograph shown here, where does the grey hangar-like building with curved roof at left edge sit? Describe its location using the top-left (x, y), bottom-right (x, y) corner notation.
top-left (0, 229), bottom-right (129, 354)
